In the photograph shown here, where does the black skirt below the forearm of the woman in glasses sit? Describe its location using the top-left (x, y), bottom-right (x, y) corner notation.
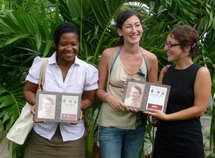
top-left (153, 119), bottom-right (204, 158)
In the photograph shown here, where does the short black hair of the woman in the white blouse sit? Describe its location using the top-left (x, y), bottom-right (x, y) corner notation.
top-left (54, 22), bottom-right (80, 48)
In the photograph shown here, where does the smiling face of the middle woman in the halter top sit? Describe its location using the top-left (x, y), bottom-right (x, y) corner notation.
top-left (117, 15), bottom-right (143, 44)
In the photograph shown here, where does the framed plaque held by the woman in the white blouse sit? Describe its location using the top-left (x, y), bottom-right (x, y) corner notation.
top-left (35, 91), bottom-right (81, 122)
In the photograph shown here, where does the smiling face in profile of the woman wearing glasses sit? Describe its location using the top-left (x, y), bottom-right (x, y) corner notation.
top-left (164, 35), bottom-right (189, 62)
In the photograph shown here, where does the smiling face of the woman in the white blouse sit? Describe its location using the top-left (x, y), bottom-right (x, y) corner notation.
top-left (58, 32), bottom-right (79, 64)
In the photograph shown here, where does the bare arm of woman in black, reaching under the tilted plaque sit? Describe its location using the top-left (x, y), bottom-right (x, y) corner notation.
top-left (145, 67), bottom-right (211, 121)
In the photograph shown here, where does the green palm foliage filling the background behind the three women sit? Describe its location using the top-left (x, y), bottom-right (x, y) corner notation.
top-left (0, 0), bottom-right (215, 158)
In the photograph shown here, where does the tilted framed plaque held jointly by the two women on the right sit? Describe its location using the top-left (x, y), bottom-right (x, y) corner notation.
top-left (123, 79), bottom-right (170, 112)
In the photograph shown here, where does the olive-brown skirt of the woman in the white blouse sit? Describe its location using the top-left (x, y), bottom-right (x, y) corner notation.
top-left (24, 127), bottom-right (86, 158)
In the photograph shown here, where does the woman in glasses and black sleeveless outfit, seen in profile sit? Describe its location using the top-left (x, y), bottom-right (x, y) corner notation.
top-left (145, 26), bottom-right (211, 158)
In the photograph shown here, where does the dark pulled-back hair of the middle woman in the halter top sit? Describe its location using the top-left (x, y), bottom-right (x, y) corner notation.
top-left (116, 10), bottom-right (142, 46)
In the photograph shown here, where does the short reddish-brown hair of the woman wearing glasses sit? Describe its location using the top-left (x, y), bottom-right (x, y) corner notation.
top-left (169, 25), bottom-right (199, 58)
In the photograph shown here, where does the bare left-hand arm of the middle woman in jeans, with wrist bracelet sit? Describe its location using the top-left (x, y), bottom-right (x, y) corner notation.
top-left (96, 48), bottom-right (126, 111)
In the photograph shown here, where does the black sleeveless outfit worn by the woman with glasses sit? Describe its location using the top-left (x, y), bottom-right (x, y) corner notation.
top-left (153, 64), bottom-right (204, 158)
